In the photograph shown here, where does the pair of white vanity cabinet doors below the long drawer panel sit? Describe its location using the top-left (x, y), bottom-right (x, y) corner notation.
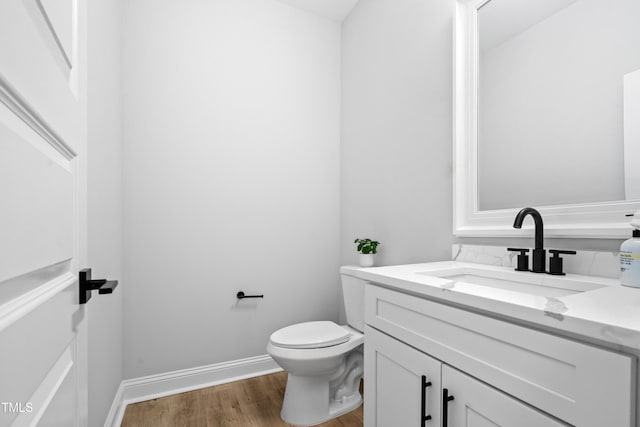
top-left (365, 327), bottom-right (567, 427)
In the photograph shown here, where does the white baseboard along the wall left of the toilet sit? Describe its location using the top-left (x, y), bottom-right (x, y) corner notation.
top-left (104, 354), bottom-right (282, 427)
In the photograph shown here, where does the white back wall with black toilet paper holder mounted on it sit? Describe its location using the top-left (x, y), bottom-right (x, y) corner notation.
top-left (123, 0), bottom-right (340, 378)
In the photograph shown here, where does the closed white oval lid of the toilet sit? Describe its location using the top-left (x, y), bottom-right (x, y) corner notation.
top-left (271, 321), bottom-right (351, 348)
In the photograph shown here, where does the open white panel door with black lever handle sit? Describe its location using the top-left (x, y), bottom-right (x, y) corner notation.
top-left (0, 0), bottom-right (87, 427)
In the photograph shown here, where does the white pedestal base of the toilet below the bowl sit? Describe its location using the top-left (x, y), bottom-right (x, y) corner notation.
top-left (280, 374), bottom-right (362, 426)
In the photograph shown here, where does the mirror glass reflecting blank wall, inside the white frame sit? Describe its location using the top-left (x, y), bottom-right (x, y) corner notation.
top-left (477, 0), bottom-right (640, 211)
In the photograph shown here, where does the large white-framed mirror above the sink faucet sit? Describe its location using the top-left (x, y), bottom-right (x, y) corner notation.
top-left (454, 0), bottom-right (640, 238)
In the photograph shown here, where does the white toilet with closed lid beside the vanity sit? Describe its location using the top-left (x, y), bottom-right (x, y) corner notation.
top-left (267, 267), bottom-right (365, 426)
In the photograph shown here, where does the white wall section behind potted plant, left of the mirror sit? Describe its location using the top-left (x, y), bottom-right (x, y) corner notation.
top-left (341, 0), bottom-right (455, 265)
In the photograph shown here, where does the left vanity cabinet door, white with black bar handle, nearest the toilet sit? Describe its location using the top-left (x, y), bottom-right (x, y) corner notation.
top-left (364, 326), bottom-right (441, 427)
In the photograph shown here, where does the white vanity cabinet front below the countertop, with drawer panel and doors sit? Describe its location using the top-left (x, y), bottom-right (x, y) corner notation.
top-left (364, 284), bottom-right (636, 427)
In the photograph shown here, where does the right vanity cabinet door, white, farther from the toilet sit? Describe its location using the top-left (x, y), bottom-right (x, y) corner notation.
top-left (442, 365), bottom-right (569, 427)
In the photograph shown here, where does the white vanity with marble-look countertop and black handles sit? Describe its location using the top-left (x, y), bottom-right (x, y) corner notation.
top-left (358, 261), bottom-right (640, 427)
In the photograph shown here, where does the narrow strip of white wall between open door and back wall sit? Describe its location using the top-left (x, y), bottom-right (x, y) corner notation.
top-left (87, 0), bottom-right (126, 426)
